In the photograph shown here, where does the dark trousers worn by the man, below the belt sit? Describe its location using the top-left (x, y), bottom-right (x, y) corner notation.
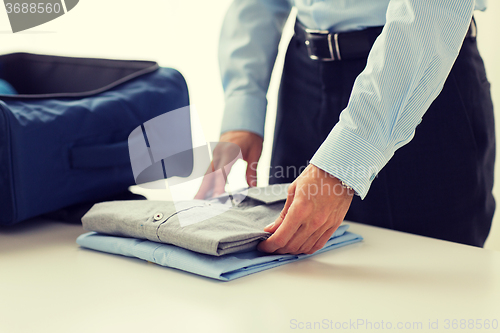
top-left (270, 24), bottom-right (495, 247)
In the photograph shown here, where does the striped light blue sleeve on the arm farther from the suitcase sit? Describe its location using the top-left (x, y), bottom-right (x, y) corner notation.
top-left (311, 0), bottom-right (474, 199)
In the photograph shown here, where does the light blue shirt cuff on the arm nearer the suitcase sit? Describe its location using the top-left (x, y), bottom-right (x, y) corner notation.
top-left (221, 95), bottom-right (267, 138)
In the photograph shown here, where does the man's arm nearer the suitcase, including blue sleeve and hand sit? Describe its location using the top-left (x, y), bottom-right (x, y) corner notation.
top-left (195, 0), bottom-right (291, 199)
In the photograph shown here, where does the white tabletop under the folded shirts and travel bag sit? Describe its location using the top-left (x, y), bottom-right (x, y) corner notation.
top-left (0, 221), bottom-right (500, 333)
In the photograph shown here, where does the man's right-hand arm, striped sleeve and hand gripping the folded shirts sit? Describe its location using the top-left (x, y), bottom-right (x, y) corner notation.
top-left (259, 0), bottom-right (474, 253)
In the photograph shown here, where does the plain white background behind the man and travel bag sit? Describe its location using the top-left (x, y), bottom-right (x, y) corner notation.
top-left (0, 0), bottom-right (500, 250)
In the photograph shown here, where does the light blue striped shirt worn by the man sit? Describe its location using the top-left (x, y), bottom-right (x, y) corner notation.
top-left (219, 0), bottom-right (486, 198)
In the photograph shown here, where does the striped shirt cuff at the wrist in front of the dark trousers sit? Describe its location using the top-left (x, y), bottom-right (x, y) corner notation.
top-left (311, 124), bottom-right (393, 199)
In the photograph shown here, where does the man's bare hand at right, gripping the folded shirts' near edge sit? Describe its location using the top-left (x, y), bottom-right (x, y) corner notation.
top-left (258, 164), bottom-right (354, 254)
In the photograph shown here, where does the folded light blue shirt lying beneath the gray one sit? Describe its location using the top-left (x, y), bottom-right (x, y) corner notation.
top-left (76, 224), bottom-right (363, 281)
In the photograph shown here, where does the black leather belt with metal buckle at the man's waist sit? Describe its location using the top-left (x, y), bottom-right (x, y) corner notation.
top-left (295, 19), bottom-right (477, 61)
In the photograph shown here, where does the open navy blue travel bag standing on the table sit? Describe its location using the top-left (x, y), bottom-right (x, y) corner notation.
top-left (0, 53), bottom-right (191, 225)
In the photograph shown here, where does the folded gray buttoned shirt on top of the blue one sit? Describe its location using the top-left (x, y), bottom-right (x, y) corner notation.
top-left (82, 184), bottom-right (289, 256)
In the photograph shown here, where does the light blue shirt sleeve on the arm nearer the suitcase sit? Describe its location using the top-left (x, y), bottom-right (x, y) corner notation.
top-left (219, 0), bottom-right (291, 137)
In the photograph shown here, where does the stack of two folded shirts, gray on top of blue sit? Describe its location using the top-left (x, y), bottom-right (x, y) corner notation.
top-left (77, 185), bottom-right (362, 281)
